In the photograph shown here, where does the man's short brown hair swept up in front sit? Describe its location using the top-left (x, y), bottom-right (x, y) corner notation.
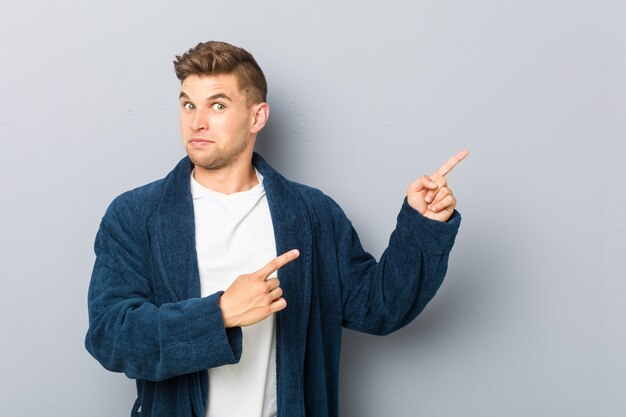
top-left (174, 41), bottom-right (267, 106)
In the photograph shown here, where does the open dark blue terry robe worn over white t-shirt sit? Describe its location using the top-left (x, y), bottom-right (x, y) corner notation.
top-left (85, 154), bottom-right (461, 417)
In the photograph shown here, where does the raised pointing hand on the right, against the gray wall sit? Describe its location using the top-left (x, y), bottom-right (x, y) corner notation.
top-left (407, 150), bottom-right (469, 222)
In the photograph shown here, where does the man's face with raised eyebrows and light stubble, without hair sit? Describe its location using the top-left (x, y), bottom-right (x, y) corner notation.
top-left (179, 74), bottom-right (256, 170)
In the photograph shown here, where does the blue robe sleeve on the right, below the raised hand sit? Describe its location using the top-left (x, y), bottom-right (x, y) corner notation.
top-left (331, 199), bottom-right (461, 335)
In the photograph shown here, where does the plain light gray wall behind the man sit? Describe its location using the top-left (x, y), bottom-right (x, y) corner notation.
top-left (0, 0), bottom-right (626, 417)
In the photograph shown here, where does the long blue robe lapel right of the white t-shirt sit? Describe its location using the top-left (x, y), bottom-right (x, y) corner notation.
top-left (252, 153), bottom-right (313, 415)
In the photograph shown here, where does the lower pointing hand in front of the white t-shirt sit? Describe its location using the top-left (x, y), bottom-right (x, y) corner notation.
top-left (219, 249), bottom-right (300, 328)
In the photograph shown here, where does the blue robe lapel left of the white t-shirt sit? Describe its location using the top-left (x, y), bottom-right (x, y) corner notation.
top-left (154, 157), bottom-right (200, 301)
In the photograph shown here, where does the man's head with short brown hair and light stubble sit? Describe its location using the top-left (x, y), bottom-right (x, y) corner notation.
top-left (174, 42), bottom-right (269, 175)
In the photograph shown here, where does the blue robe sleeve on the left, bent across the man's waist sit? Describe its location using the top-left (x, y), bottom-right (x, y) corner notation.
top-left (85, 197), bottom-right (242, 381)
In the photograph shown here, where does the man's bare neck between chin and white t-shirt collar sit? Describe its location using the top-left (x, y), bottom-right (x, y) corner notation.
top-left (193, 158), bottom-right (259, 194)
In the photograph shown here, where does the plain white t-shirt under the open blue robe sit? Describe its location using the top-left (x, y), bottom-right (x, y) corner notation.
top-left (191, 172), bottom-right (276, 417)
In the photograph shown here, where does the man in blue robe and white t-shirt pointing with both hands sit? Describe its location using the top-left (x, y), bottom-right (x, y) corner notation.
top-left (85, 42), bottom-right (467, 417)
